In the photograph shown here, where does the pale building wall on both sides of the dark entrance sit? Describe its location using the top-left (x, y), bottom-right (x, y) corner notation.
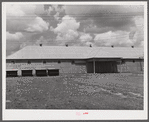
top-left (6, 60), bottom-right (144, 76)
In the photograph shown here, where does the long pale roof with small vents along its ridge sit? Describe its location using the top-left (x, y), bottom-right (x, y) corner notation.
top-left (7, 46), bottom-right (143, 59)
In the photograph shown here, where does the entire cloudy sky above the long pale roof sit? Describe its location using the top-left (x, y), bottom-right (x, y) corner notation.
top-left (6, 4), bottom-right (144, 55)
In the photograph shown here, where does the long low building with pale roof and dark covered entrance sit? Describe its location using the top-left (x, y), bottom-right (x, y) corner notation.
top-left (6, 46), bottom-right (144, 76)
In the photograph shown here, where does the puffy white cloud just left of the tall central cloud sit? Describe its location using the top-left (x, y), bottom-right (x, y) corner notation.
top-left (25, 17), bottom-right (49, 32)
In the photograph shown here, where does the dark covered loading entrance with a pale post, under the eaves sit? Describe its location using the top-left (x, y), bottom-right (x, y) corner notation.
top-left (87, 58), bottom-right (121, 73)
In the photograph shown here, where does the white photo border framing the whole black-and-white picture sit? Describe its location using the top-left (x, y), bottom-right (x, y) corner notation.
top-left (2, 1), bottom-right (148, 120)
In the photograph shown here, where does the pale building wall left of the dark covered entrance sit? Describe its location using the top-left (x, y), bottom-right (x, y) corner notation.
top-left (6, 62), bottom-right (86, 76)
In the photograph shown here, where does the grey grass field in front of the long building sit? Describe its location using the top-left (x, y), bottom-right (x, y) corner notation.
top-left (6, 73), bottom-right (143, 110)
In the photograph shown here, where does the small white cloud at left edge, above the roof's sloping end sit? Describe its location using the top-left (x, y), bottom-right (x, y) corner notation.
top-left (6, 32), bottom-right (23, 41)
